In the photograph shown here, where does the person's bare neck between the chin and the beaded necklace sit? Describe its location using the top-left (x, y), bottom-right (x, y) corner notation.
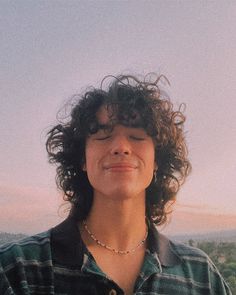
top-left (82, 192), bottom-right (146, 250)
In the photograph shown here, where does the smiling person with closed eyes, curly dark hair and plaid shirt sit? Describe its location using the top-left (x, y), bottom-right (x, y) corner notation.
top-left (0, 75), bottom-right (231, 295)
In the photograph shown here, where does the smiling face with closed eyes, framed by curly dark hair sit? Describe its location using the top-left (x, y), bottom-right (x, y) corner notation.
top-left (83, 107), bottom-right (156, 200)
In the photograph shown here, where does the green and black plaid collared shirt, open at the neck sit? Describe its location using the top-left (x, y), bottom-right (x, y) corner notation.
top-left (0, 217), bottom-right (232, 295)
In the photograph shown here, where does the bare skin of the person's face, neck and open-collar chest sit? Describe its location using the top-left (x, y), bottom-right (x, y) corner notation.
top-left (79, 107), bottom-right (156, 295)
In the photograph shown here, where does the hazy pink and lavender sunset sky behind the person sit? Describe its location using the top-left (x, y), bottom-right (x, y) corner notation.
top-left (0, 0), bottom-right (236, 233)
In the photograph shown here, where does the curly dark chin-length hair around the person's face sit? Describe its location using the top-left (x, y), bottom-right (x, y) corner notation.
top-left (46, 75), bottom-right (191, 225)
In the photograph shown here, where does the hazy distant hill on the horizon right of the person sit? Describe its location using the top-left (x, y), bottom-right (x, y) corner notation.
top-left (169, 229), bottom-right (236, 243)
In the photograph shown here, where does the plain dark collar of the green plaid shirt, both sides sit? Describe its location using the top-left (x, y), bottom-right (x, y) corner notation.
top-left (51, 216), bottom-right (181, 268)
